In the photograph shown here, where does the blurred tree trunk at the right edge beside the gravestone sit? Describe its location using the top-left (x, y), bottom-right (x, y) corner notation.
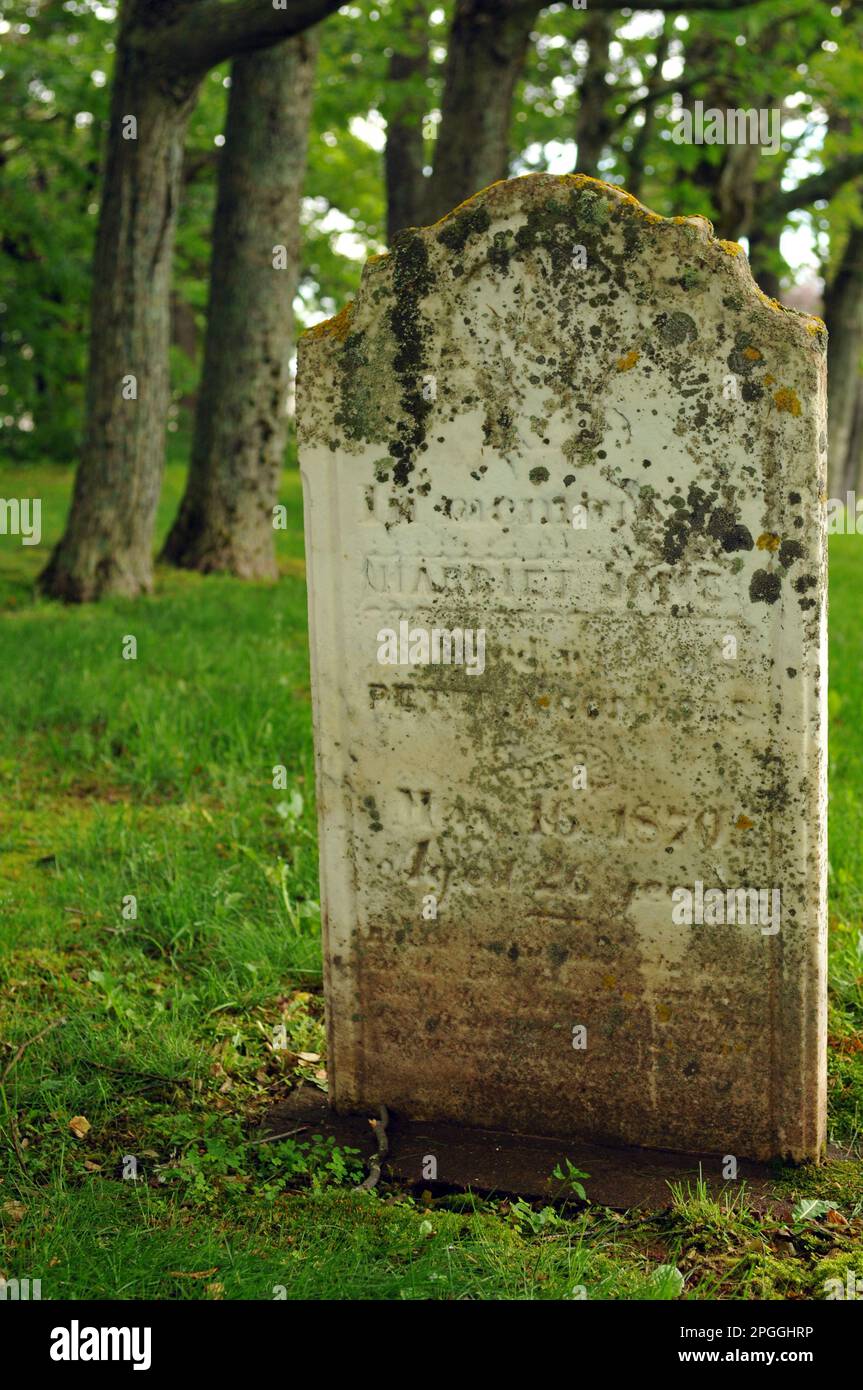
top-left (824, 225), bottom-right (863, 498)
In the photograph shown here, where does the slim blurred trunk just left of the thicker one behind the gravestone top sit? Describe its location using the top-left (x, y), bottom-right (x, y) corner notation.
top-left (384, 0), bottom-right (431, 245)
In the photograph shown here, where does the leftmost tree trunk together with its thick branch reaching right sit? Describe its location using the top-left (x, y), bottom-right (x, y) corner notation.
top-left (40, 0), bottom-right (339, 602)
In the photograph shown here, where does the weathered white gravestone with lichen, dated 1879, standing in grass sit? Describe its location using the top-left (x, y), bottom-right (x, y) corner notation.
top-left (297, 175), bottom-right (827, 1159)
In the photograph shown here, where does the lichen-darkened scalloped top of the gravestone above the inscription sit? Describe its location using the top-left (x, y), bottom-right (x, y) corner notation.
top-left (297, 174), bottom-right (827, 494)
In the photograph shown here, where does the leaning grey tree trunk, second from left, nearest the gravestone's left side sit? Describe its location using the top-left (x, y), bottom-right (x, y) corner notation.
top-left (163, 33), bottom-right (317, 580)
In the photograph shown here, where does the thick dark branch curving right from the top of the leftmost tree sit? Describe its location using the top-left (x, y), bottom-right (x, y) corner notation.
top-left (129, 0), bottom-right (343, 75)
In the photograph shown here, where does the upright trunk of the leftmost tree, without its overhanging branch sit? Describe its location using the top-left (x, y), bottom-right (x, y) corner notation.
top-left (40, 7), bottom-right (197, 603)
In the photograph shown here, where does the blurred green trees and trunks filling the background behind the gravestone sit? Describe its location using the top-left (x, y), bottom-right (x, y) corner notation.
top-left (0, 0), bottom-right (863, 599)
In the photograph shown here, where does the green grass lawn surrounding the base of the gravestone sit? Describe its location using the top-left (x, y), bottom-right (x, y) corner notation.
top-left (0, 464), bottom-right (863, 1300)
